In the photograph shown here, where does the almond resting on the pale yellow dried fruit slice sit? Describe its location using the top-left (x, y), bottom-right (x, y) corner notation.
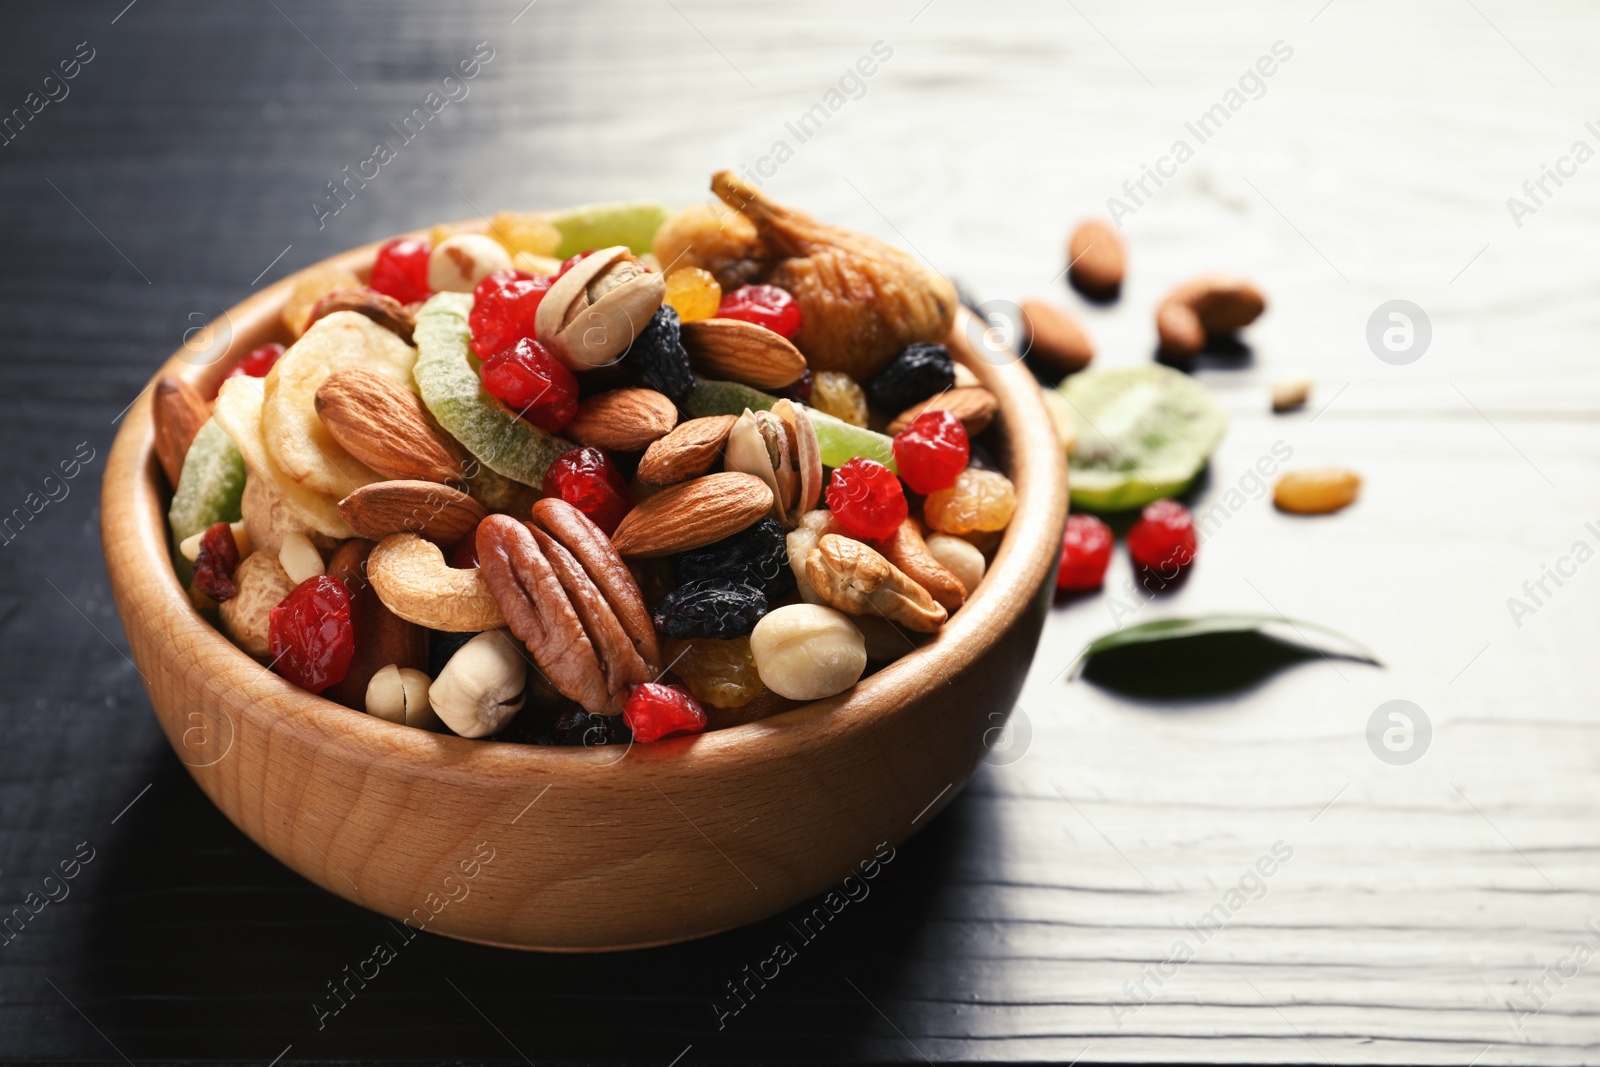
top-left (317, 366), bottom-right (469, 482)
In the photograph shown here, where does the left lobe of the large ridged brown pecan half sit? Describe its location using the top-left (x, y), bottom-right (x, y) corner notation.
top-left (477, 515), bottom-right (610, 713)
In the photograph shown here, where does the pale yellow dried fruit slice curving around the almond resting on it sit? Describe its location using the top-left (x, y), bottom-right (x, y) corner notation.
top-left (261, 312), bottom-right (416, 499)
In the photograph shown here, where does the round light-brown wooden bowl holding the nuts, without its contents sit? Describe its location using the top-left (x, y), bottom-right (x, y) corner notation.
top-left (101, 224), bottom-right (1067, 952)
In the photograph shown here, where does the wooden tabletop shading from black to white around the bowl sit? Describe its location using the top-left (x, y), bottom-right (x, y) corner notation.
top-left (0, 0), bottom-right (1600, 1064)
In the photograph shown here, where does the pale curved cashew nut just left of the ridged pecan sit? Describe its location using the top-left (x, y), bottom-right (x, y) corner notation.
top-left (366, 534), bottom-right (506, 633)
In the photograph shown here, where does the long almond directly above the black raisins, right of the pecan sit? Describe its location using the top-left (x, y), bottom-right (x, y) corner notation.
top-left (611, 472), bottom-right (773, 560)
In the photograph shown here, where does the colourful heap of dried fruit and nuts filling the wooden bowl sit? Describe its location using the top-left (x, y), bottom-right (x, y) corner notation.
top-left (155, 171), bottom-right (1016, 744)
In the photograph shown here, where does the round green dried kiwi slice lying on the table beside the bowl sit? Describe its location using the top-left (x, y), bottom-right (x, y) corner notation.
top-left (1061, 363), bottom-right (1227, 512)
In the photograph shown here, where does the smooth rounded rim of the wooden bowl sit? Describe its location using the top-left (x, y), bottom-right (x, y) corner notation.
top-left (101, 218), bottom-right (1067, 781)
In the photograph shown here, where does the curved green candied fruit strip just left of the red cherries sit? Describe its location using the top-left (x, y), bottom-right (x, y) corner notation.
top-left (411, 293), bottom-right (573, 486)
